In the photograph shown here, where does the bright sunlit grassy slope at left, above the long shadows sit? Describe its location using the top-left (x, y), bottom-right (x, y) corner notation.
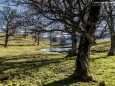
top-left (0, 35), bottom-right (50, 56)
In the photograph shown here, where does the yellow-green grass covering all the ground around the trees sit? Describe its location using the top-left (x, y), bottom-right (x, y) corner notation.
top-left (0, 36), bottom-right (115, 86)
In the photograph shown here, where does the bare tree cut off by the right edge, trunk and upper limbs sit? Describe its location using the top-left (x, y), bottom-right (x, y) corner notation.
top-left (103, 3), bottom-right (115, 56)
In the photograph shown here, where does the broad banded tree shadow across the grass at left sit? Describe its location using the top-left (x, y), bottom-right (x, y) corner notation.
top-left (0, 54), bottom-right (74, 82)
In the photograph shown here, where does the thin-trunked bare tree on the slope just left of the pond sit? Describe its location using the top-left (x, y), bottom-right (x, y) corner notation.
top-left (21, 9), bottom-right (44, 45)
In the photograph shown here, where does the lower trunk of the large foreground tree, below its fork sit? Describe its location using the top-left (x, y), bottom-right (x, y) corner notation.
top-left (75, 36), bottom-right (91, 80)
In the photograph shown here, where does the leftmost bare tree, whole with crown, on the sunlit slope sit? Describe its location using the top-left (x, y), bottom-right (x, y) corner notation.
top-left (0, 6), bottom-right (19, 47)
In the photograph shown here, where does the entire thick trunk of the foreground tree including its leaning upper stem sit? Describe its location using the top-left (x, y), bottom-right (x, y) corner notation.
top-left (74, 0), bottom-right (100, 81)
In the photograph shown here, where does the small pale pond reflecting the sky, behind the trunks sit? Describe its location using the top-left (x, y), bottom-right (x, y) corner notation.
top-left (41, 48), bottom-right (71, 52)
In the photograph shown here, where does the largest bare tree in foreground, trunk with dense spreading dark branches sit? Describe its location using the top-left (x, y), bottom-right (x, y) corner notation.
top-left (13, 0), bottom-right (105, 81)
